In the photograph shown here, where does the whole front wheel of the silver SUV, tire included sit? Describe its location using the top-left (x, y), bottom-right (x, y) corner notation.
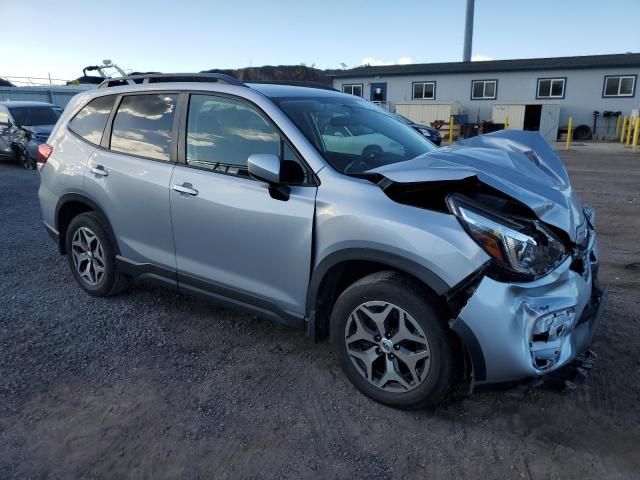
top-left (331, 271), bottom-right (456, 409)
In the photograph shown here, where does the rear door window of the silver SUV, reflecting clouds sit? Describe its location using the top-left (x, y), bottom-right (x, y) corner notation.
top-left (111, 93), bottom-right (177, 162)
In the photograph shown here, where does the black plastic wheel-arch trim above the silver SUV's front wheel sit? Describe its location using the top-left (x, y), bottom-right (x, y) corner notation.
top-left (305, 248), bottom-right (451, 337)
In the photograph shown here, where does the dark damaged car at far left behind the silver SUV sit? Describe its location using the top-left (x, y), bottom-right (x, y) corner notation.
top-left (0, 102), bottom-right (63, 169)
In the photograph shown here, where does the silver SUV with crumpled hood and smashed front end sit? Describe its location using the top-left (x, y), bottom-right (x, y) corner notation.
top-left (38, 74), bottom-right (605, 408)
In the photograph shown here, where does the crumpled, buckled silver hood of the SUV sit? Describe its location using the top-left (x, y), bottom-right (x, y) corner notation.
top-left (370, 130), bottom-right (585, 242)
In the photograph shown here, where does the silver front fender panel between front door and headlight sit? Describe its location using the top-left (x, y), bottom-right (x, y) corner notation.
top-left (313, 169), bottom-right (489, 287)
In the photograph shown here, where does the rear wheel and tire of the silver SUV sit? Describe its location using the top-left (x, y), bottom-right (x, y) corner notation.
top-left (65, 212), bottom-right (131, 297)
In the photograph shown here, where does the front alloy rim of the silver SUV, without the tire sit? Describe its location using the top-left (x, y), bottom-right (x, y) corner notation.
top-left (344, 301), bottom-right (431, 393)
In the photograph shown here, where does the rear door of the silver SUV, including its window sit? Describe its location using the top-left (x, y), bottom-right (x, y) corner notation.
top-left (82, 92), bottom-right (178, 268)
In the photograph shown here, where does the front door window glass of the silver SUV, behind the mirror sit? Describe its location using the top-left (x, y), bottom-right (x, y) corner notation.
top-left (187, 95), bottom-right (280, 174)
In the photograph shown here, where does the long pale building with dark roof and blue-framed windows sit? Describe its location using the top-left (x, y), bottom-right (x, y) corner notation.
top-left (328, 53), bottom-right (640, 139)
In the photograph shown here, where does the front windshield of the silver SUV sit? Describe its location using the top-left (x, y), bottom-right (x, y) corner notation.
top-left (273, 95), bottom-right (436, 175)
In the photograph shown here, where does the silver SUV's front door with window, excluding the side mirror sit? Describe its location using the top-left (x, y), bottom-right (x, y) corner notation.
top-left (171, 95), bottom-right (316, 317)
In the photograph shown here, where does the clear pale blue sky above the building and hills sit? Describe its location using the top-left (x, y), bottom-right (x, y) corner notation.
top-left (0, 0), bottom-right (640, 79)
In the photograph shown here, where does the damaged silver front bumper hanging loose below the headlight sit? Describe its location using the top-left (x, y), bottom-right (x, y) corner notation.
top-left (451, 229), bottom-right (607, 384)
